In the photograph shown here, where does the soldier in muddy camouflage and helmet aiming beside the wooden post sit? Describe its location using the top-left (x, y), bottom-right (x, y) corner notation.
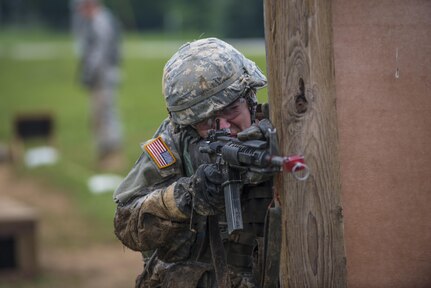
top-left (114, 38), bottom-right (273, 288)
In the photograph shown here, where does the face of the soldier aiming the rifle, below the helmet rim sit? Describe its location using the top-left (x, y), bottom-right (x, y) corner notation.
top-left (193, 98), bottom-right (251, 138)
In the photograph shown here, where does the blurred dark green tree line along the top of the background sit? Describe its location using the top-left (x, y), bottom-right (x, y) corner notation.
top-left (0, 0), bottom-right (264, 38)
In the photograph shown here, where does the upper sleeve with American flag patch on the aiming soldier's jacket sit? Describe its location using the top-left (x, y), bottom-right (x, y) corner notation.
top-left (114, 121), bottom-right (183, 204)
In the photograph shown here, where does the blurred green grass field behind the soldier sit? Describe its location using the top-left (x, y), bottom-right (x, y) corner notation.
top-left (0, 32), bottom-right (266, 239)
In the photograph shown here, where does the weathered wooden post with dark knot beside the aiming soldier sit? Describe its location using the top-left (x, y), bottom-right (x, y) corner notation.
top-left (264, 0), bottom-right (347, 288)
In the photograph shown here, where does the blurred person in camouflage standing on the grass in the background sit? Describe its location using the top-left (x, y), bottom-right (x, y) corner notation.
top-left (71, 0), bottom-right (123, 170)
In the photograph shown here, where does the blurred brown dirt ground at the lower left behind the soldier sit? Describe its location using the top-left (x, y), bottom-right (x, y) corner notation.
top-left (0, 164), bottom-right (142, 288)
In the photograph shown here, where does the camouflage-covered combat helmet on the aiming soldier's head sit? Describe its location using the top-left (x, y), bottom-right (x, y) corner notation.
top-left (162, 38), bottom-right (266, 127)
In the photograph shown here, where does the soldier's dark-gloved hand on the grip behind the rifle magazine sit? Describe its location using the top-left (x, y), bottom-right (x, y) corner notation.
top-left (192, 164), bottom-right (224, 216)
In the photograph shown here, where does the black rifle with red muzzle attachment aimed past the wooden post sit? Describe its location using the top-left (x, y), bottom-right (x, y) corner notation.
top-left (199, 129), bottom-right (309, 234)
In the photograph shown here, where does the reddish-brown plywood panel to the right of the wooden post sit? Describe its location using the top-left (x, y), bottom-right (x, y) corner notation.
top-left (333, 0), bottom-right (431, 288)
